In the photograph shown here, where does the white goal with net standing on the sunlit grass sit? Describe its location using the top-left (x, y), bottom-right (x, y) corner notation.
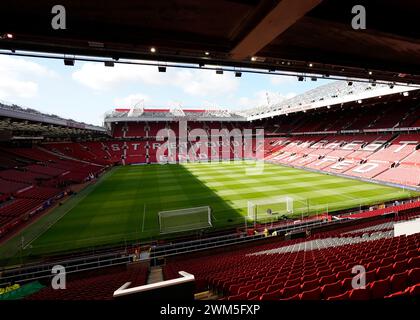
top-left (248, 197), bottom-right (293, 221)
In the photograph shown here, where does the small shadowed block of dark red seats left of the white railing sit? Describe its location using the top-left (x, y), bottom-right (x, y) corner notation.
top-left (27, 267), bottom-right (148, 300)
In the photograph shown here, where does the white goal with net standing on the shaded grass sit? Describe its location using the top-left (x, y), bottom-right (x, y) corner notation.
top-left (158, 206), bottom-right (212, 233)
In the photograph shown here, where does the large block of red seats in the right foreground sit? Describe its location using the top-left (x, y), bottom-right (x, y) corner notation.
top-left (165, 222), bottom-right (420, 300)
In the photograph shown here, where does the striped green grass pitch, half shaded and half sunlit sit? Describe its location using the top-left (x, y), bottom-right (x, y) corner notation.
top-left (0, 162), bottom-right (414, 255)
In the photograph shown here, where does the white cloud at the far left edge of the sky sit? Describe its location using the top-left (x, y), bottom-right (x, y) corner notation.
top-left (0, 56), bottom-right (57, 99)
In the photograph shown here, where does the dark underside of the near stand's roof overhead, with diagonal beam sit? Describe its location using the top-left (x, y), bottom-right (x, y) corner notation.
top-left (0, 0), bottom-right (420, 84)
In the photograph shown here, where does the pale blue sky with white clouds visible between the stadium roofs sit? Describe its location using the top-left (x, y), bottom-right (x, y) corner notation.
top-left (0, 55), bottom-right (329, 125)
